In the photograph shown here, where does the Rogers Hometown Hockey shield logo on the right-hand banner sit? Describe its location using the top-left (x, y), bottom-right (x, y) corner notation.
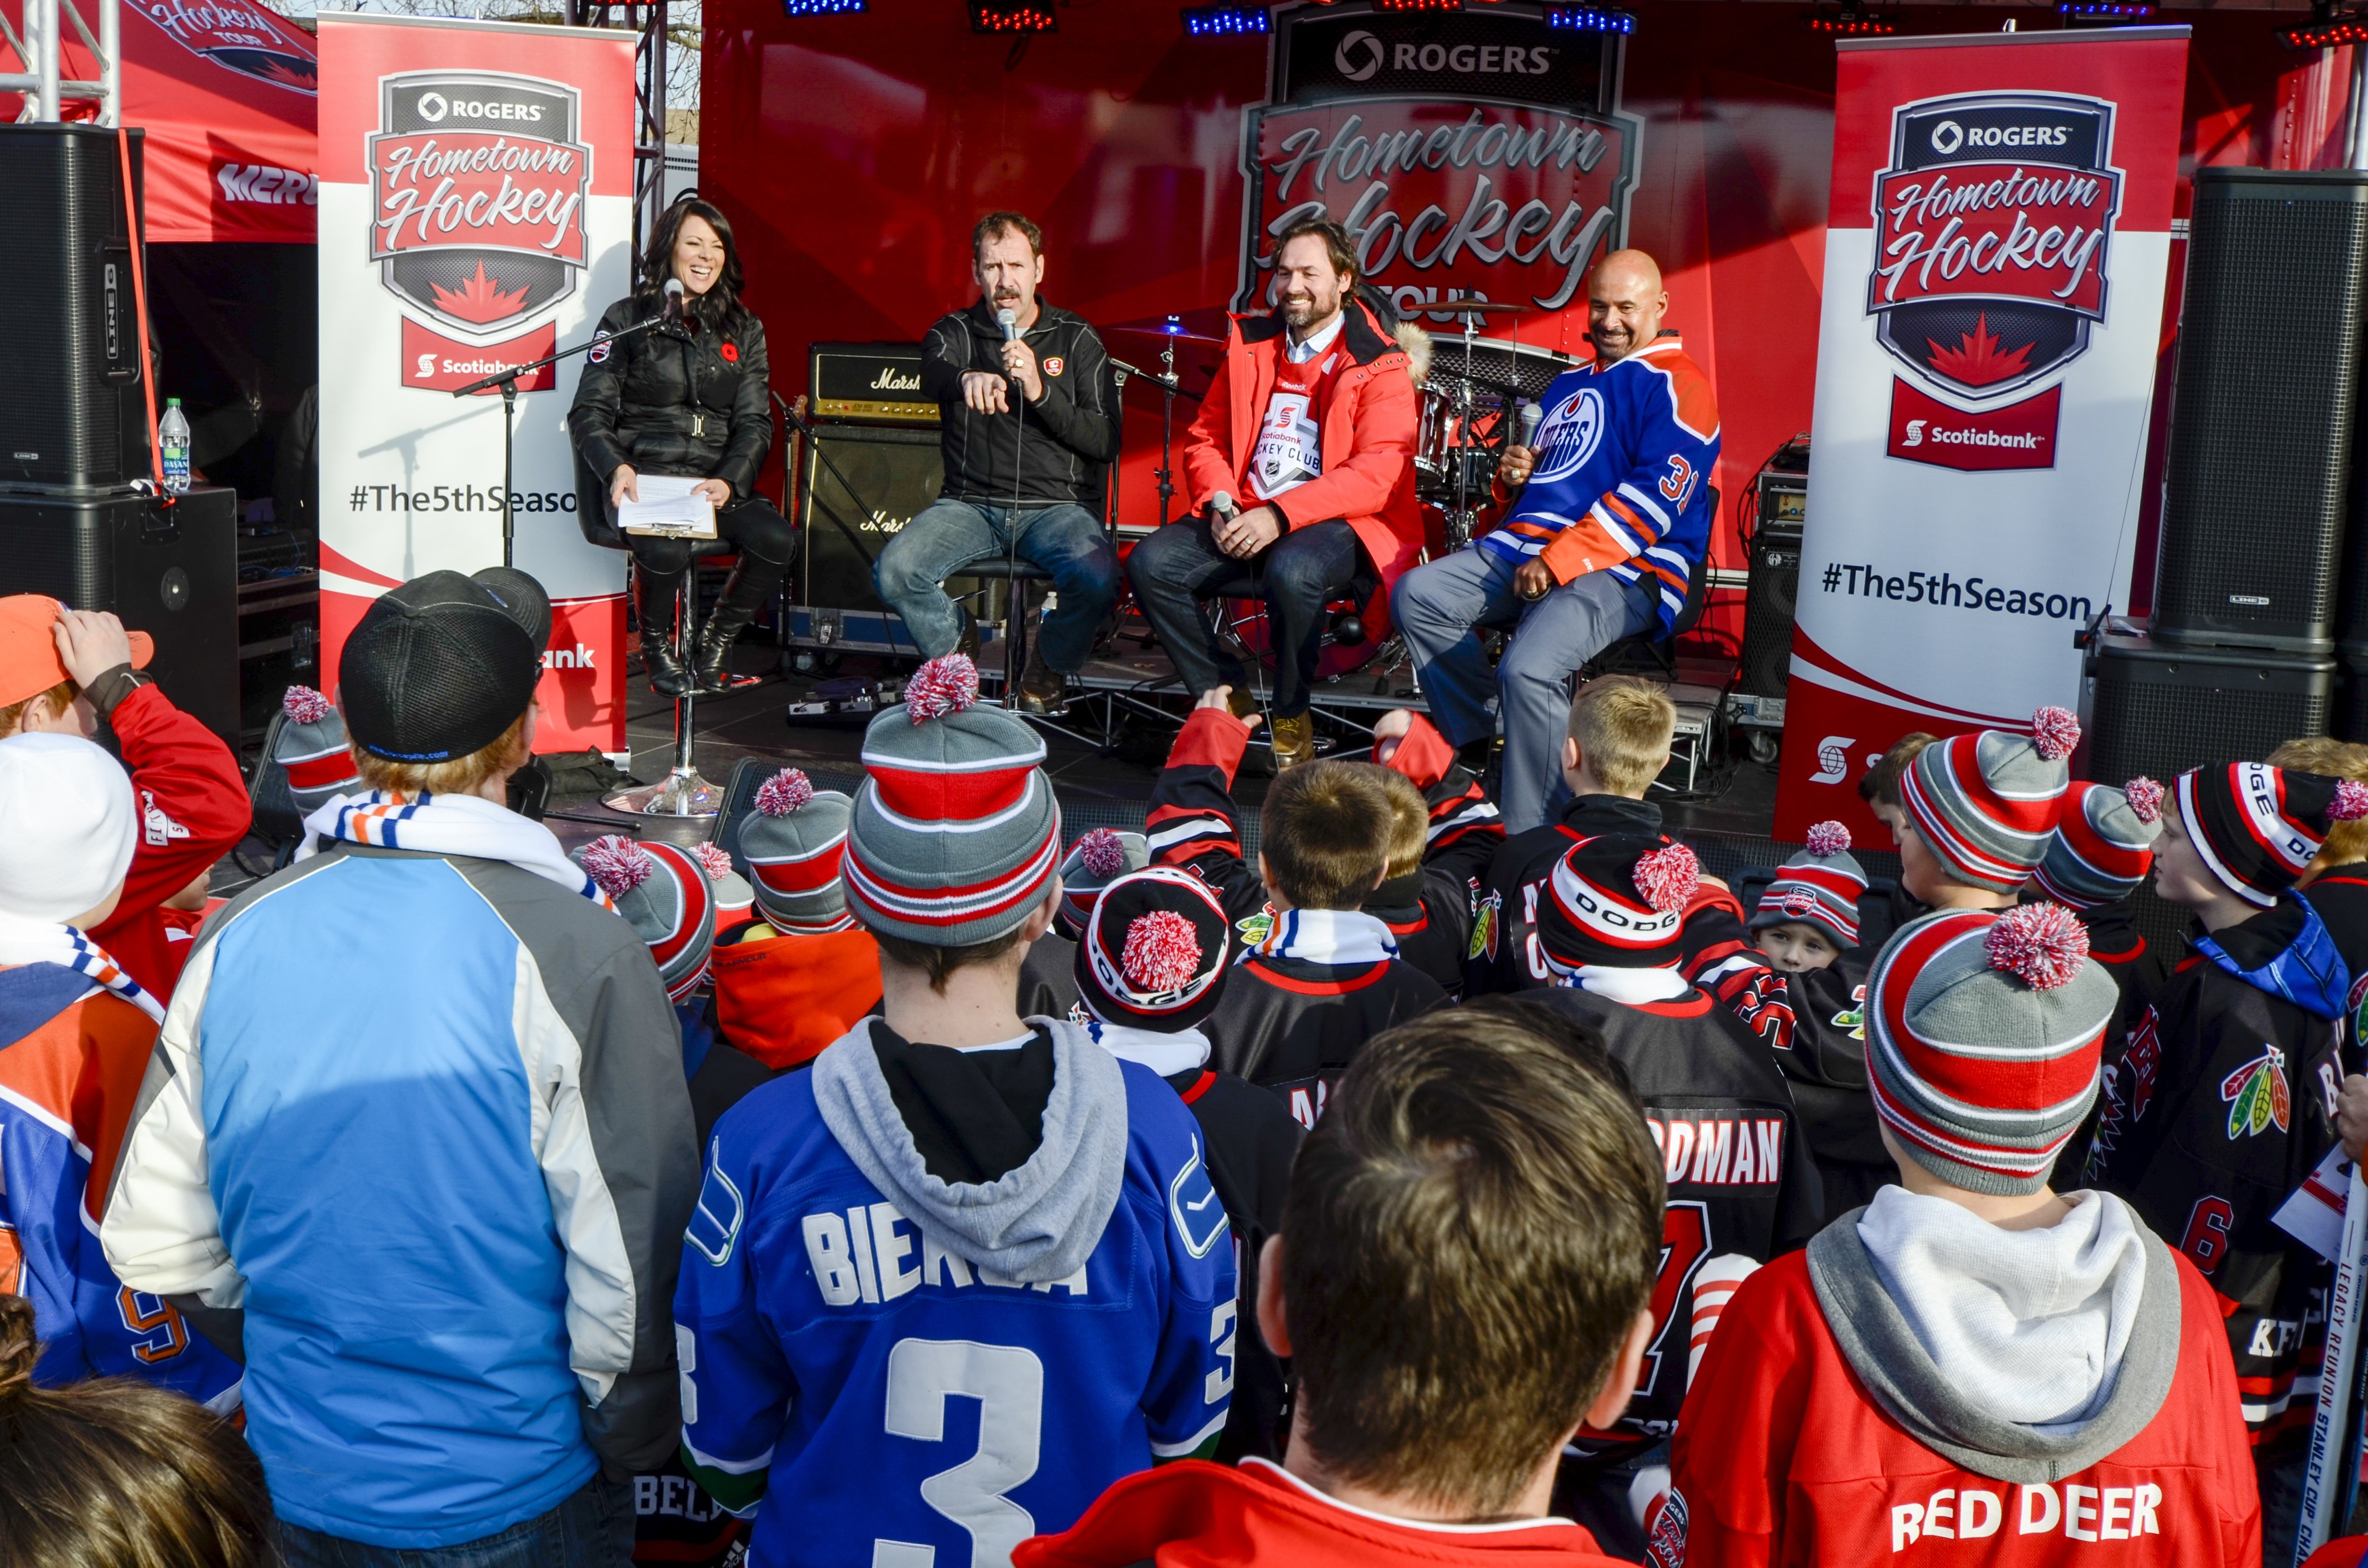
top-left (1866, 92), bottom-right (2121, 400)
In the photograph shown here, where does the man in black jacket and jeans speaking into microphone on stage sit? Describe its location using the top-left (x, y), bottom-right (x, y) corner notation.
top-left (871, 213), bottom-right (1118, 713)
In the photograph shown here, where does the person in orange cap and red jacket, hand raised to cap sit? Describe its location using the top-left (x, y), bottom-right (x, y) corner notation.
top-left (0, 594), bottom-right (253, 1002)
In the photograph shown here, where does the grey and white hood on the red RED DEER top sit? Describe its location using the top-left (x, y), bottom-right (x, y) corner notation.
top-left (1809, 1187), bottom-right (2178, 1485)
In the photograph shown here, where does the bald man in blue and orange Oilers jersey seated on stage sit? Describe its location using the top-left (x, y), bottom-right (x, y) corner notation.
top-left (1390, 251), bottom-right (1719, 834)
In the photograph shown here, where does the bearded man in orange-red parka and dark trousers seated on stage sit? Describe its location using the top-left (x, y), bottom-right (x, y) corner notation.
top-left (1127, 218), bottom-right (1423, 768)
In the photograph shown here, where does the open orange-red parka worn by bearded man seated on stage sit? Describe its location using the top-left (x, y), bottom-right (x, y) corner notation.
top-left (1184, 301), bottom-right (1423, 604)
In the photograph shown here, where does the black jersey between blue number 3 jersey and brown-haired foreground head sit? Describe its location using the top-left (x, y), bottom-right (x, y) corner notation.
top-left (1167, 1068), bottom-right (1305, 1464)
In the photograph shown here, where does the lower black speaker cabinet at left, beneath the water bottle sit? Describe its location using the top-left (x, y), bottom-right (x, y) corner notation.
top-left (0, 485), bottom-right (239, 751)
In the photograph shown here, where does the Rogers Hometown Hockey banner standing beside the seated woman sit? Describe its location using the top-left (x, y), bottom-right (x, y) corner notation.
top-left (320, 12), bottom-right (632, 753)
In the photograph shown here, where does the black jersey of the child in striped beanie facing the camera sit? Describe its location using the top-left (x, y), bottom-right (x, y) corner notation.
top-left (1712, 950), bottom-right (1899, 1215)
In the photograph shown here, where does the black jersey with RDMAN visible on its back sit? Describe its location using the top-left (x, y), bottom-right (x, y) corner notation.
top-left (1544, 971), bottom-right (1826, 1461)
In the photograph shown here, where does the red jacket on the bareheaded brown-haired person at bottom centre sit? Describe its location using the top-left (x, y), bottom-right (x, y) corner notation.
top-left (1011, 1459), bottom-right (1622, 1568)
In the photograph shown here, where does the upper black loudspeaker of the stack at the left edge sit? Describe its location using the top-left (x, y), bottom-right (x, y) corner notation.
top-left (0, 125), bottom-right (150, 490)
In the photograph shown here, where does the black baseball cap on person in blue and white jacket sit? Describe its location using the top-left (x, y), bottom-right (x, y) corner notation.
top-left (336, 568), bottom-right (551, 763)
